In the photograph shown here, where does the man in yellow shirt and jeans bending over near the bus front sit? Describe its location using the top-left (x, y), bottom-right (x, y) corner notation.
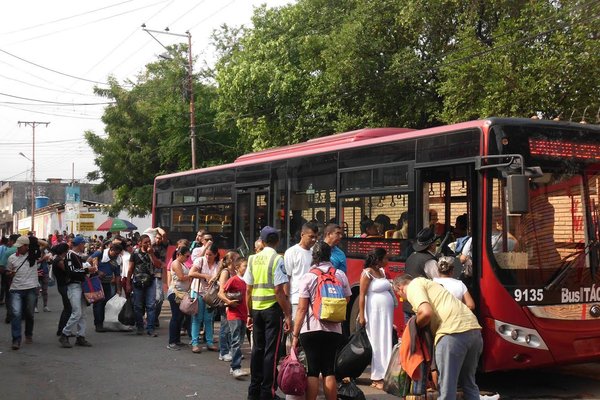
top-left (394, 274), bottom-right (483, 400)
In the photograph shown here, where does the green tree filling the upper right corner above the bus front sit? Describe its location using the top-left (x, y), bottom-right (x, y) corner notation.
top-left (439, 0), bottom-right (600, 122)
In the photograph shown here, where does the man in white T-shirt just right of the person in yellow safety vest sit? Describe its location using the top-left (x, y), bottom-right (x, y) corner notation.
top-left (283, 222), bottom-right (319, 318)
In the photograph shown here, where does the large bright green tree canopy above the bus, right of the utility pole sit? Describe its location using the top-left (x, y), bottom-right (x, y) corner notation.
top-left (215, 0), bottom-right (600, 151)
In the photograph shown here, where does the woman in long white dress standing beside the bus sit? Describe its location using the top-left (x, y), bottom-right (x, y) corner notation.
top-left (358, 247), bottom-right (395, 390)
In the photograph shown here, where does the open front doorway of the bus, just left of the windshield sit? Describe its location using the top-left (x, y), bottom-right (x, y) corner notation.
top-left (417, 164), bottom-right (478, 276)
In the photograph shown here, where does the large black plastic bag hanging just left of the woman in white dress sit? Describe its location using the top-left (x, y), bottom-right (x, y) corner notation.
top-left (335, 327), bottom-right (373, 378)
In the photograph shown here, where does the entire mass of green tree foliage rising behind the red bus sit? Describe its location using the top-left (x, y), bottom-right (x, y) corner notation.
top-left (86, 0), bottom-right (600, 214)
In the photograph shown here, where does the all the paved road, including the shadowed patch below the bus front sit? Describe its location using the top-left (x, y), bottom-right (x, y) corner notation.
top-left (0, 288), bottom-right (600, 400)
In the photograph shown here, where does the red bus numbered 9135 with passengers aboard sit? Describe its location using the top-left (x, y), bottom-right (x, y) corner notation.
top-left (153, 118), bottom-right (600, 371)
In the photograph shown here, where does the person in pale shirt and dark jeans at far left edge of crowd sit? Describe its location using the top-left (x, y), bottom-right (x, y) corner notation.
top-left (6, 236), bottom-right (38, 350)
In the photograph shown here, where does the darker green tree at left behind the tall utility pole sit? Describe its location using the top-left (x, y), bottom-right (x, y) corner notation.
top-left (85, 46), bottom-right (236, 216)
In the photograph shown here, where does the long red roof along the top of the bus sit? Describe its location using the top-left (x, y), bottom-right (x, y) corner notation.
top-left (156, 118), bottom-right (590, 180)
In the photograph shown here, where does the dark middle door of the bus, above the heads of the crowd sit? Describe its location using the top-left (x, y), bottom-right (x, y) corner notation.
top-left (235, 185), bottom-right (269, 257)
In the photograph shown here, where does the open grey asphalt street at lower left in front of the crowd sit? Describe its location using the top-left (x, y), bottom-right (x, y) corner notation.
top-left (0, 287), bottom-right (395, 400)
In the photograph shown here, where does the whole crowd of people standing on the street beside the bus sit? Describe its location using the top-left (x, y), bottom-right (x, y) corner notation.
top-left (0, 216), bottom-right (481, 400)
